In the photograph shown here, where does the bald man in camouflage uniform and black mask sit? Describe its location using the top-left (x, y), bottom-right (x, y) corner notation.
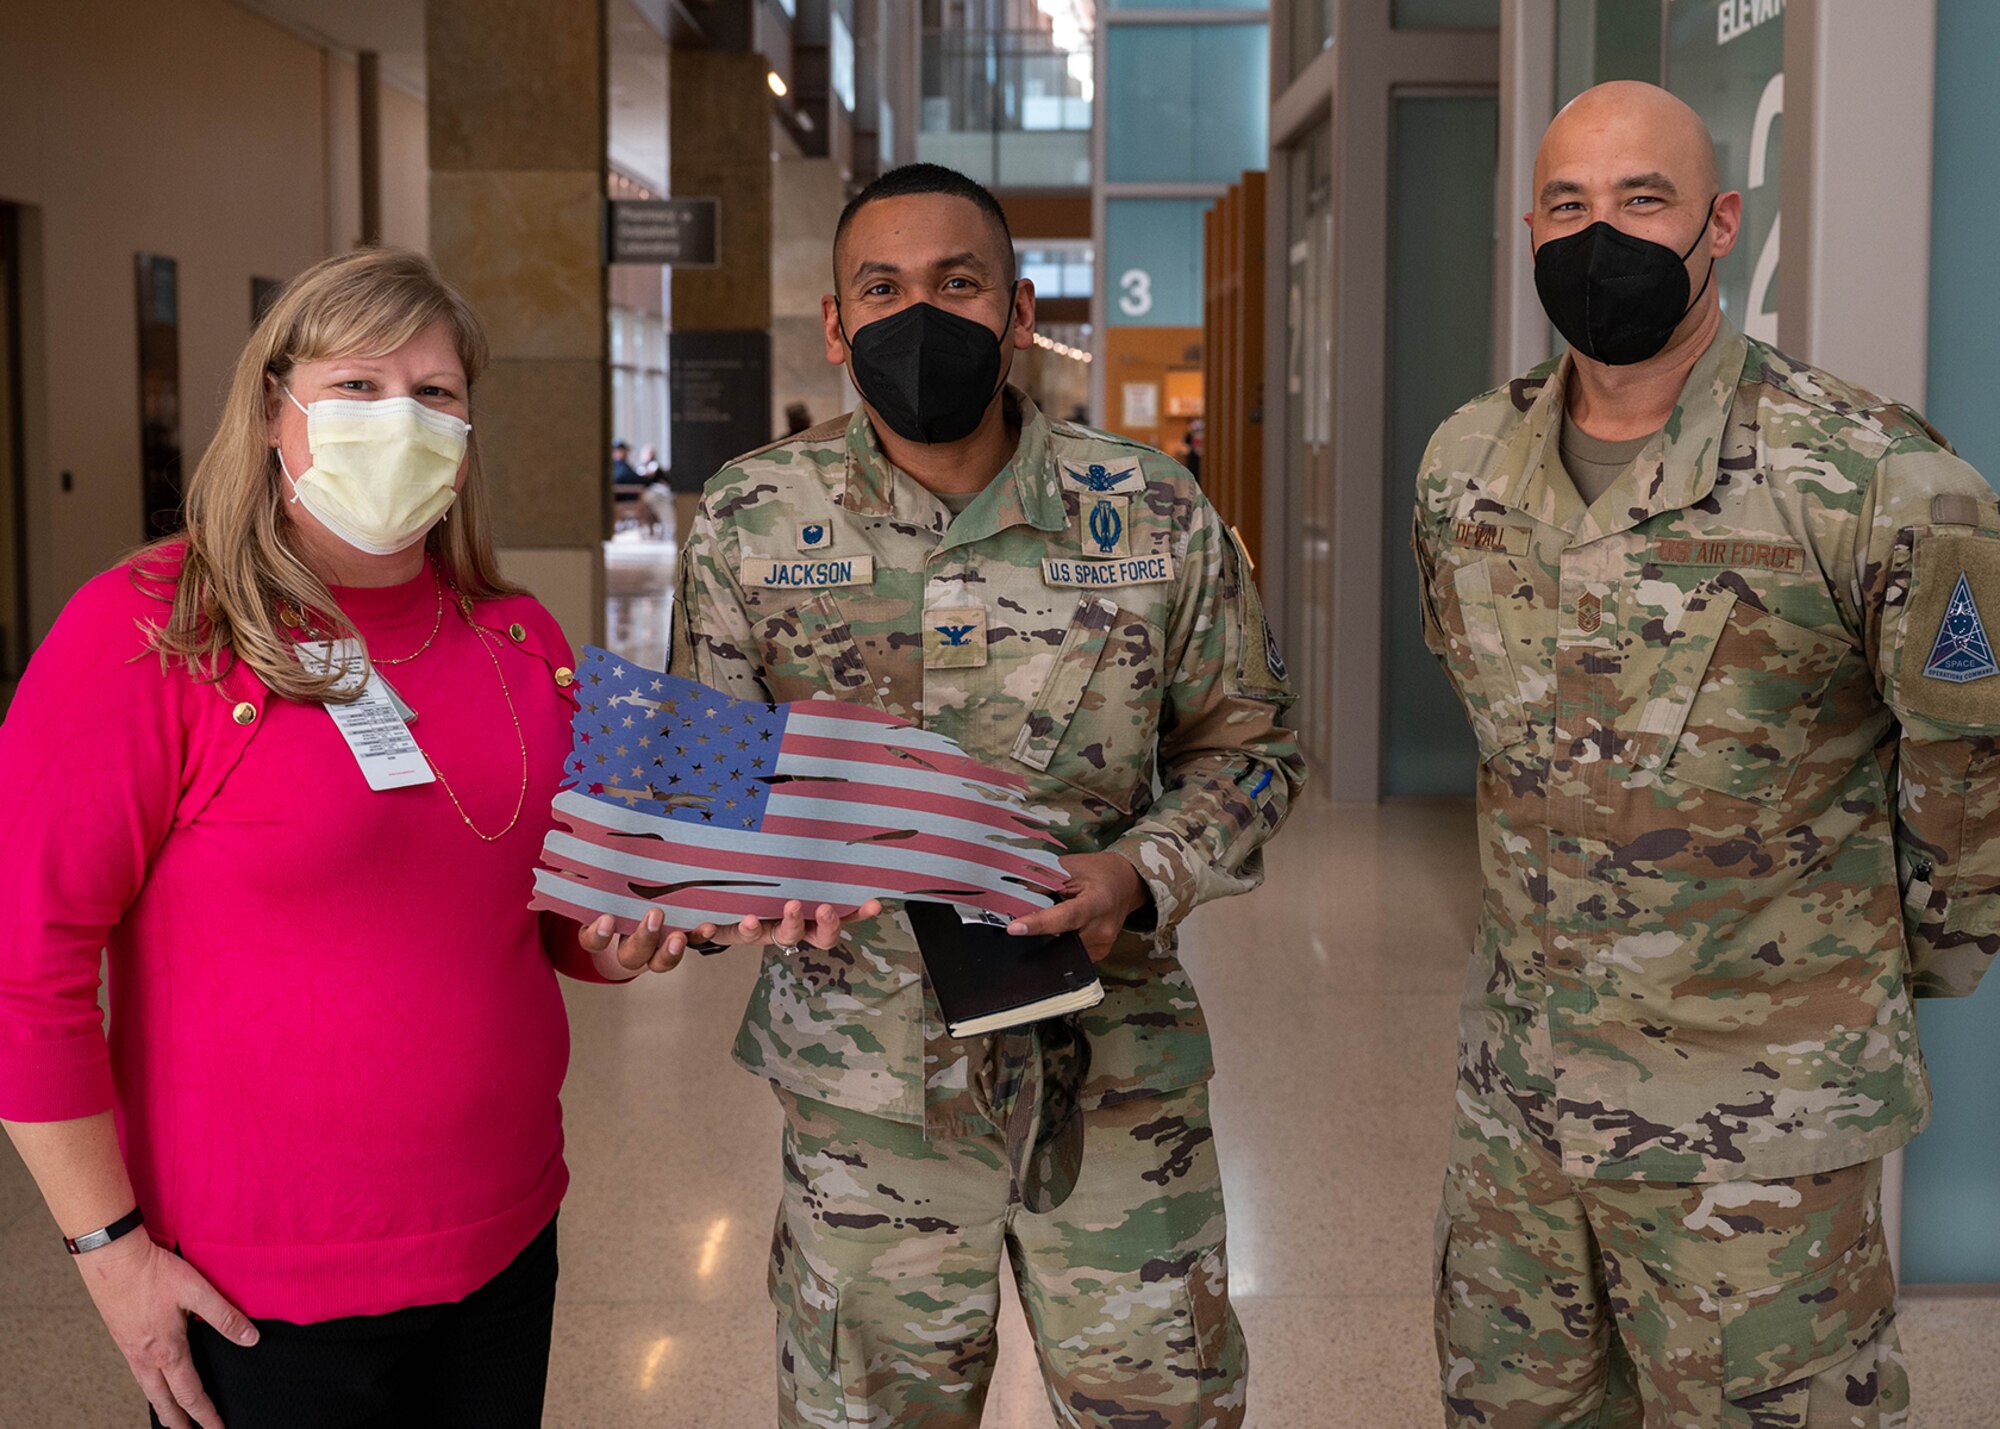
top-left (1414, 84), bottom-right (2000, 1429)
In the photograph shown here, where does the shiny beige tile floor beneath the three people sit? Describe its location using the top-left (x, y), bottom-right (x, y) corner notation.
top-left (0, 572), bottom-right (2000, 1429)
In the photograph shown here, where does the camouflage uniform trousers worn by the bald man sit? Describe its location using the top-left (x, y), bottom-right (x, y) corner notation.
top-left (1436, 1087), bottom-right (1910, 1429)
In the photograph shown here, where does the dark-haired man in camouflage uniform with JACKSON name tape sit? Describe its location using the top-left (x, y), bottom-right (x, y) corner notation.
top-left (674, 166), bottom-right (1304, 1429)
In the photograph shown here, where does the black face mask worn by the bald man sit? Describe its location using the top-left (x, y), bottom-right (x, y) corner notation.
top-left (1534, 198), bottom-right (1716, 366)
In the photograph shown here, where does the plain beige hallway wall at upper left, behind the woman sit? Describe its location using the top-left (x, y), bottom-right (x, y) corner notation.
top-left (0, 0), bottom-right (422, 638)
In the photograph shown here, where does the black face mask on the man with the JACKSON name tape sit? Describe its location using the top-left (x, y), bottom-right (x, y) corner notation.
top-left (848, 284), bottom-right (1018, 446)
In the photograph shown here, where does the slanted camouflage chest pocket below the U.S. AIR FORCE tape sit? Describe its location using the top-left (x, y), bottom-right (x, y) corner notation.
top-left (1666, 598), bottom-right (1854, 803)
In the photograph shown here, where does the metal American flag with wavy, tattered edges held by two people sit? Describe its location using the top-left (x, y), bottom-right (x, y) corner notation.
top-left (532, 648), bottom-right (1066, 933)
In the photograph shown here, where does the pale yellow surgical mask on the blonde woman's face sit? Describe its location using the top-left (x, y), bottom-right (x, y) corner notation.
top-left (278, 388), bottom-right (472, 556)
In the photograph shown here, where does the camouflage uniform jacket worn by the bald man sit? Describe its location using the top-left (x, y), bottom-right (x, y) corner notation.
top-left (1414, 328), bottom-right (2000, 1181)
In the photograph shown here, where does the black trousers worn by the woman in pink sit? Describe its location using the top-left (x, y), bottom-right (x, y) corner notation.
top-left (152, 1219), bottom-right (556, 1429)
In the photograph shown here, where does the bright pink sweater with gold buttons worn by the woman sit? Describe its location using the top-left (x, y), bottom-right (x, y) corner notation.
top-left (0, 552), bottom-right (594, 1321)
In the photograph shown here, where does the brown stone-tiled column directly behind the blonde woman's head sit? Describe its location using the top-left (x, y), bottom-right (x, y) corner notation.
top-left (424, 0), bottom-right (604, 644)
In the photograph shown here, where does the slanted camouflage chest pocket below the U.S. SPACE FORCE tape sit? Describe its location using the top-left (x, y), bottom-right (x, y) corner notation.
top-left (1010, 594), bottom-right (1162, 813)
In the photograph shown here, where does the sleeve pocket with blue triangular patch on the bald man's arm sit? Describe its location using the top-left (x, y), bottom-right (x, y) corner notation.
top-left (1890, 528), bottom-right (2000, 735)
